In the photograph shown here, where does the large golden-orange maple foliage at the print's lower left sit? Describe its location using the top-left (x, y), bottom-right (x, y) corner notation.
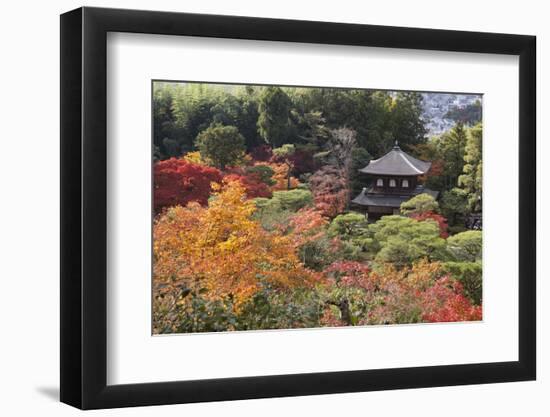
top-left (153, 181), bottom-right (315, 306)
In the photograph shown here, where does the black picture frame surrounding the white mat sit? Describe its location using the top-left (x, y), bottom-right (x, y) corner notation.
top-left (60, 7), bottom-right (536, 409)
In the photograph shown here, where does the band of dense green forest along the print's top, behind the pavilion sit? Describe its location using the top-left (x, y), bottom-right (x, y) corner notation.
top-left (153, 82), bottom-right (426, 163)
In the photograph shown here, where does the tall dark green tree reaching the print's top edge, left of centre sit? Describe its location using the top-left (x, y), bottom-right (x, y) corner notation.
top-left (258, 86), bottom-right (292, 147)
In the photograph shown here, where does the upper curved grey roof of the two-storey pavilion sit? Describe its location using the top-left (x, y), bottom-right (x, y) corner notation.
top-left (359, 142), bottom-right (432, 175)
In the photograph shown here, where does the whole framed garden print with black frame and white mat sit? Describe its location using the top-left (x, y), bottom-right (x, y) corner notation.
top-left (61, 7), bottom-right (536, 409)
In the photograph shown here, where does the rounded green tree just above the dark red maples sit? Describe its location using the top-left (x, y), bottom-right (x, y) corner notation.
top-left (196, 124), bottom-right (245, 170)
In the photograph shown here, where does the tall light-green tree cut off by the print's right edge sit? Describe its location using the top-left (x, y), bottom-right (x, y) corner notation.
top-left (458, 123), bottom-right (483, 212)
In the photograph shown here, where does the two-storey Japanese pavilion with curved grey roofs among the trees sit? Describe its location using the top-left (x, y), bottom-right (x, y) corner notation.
top-left (351, 141), bottom-right (439, 219)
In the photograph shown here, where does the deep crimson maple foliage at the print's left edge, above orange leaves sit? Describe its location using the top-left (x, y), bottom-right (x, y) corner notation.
top-left (153, 158), bottom-right (222, 213)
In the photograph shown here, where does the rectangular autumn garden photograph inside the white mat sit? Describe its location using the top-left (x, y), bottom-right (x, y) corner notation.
top-left (151, 80), bottom-right (483, 335)
